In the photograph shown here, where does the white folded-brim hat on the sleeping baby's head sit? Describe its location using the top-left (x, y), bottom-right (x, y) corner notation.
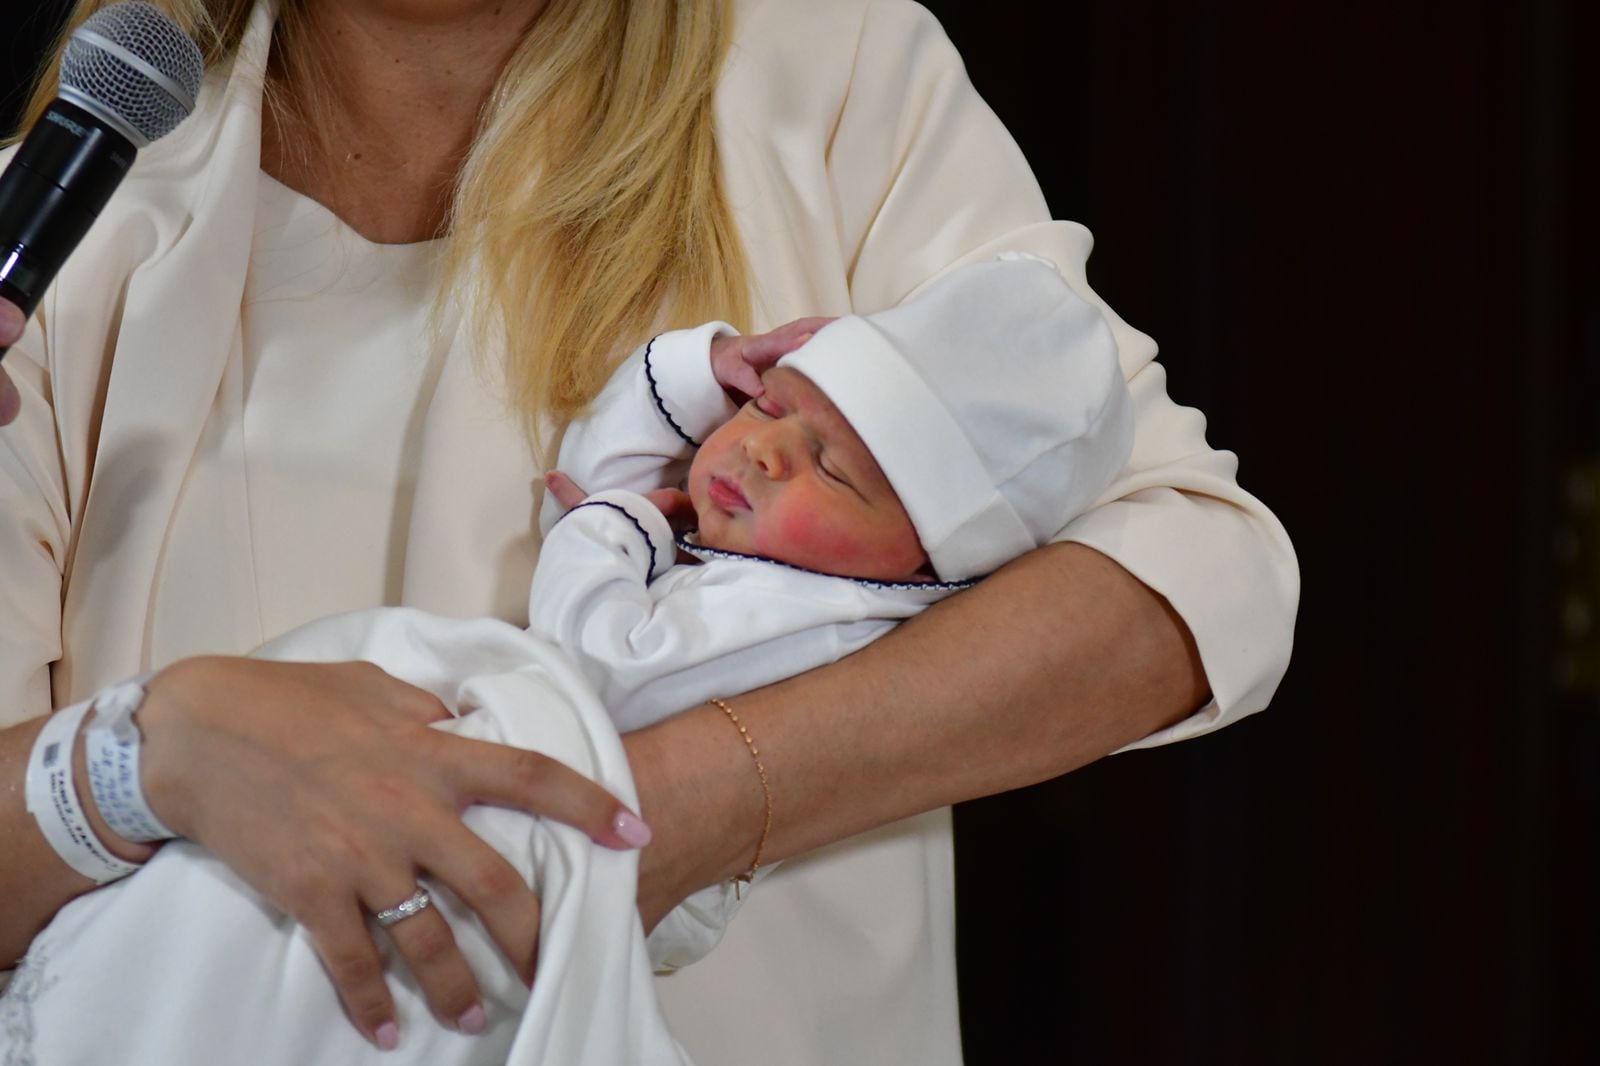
top-left (781, 253), bottom-right (1133, 581)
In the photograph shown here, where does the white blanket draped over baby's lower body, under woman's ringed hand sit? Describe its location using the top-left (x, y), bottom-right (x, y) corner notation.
top-left (0, 610), bottom-right (688, 1066)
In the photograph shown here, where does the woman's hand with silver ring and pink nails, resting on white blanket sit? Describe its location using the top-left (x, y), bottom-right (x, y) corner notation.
top-left (139, 656), bottom-right (650, 1047)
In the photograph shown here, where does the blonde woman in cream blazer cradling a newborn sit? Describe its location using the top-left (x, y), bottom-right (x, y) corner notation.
top-left (0, 0), bottom-right (1298, 1063)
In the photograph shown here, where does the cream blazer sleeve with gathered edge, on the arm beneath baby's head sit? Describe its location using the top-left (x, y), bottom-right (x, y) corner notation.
top-left (829, 0), bottom-right (1299, 747)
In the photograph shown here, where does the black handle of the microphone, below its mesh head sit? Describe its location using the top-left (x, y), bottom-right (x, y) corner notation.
top-left (0, 99), bottom-right (139, 357)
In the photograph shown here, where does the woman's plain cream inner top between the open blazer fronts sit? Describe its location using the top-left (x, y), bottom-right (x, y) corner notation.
top-left (240, 173), bottom-right (440, 639)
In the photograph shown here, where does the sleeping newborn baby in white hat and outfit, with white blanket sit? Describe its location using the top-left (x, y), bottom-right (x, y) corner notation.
top-left (9, 256), bottom-right (1133, 1066)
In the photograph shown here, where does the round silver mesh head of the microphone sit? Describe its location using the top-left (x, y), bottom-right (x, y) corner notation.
top-left (61, 0), bottom-right (205, 147)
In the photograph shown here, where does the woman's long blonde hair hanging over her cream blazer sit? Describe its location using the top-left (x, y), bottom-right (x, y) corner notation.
top-left (14, 0), bottom-right (750, 443)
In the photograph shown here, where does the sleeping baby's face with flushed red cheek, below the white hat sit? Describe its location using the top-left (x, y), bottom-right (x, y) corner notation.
top-left (688, 367), bottom-right (928, 581)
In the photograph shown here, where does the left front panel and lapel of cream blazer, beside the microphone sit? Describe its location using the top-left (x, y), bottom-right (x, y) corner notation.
top-left (54, 3), bottom-right (275, 699)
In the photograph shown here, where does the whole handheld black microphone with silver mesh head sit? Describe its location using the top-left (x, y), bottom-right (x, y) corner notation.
top-left (0, 0), bottom-right (205, 355)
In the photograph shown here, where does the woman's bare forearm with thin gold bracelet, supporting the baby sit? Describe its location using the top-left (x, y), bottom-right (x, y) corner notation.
top-left (626, 544), bottom-right (1208, 920)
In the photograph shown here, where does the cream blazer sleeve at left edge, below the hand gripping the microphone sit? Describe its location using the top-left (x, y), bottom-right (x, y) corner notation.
top-left (0, 302), bottom-right (72, 727)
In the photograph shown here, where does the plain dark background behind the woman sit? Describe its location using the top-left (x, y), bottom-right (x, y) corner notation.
top-left (0, 0), bottom-right (1600, 1066)
